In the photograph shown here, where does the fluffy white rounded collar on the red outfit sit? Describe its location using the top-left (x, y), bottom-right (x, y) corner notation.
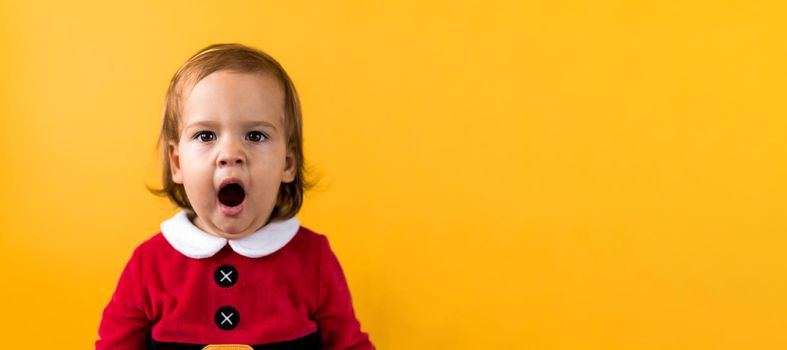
top-left (161, 210), bottom-right (301, 259)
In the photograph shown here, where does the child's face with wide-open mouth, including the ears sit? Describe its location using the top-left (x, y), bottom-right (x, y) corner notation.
top-left (168, 71), bottom-right (297, 239)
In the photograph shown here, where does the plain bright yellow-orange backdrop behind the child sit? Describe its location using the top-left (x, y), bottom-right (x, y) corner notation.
top-left (0, 0), bottom-right (787, 349)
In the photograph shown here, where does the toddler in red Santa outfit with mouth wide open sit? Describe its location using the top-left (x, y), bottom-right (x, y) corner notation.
top-left (96, 44), bottom-right (374, 349)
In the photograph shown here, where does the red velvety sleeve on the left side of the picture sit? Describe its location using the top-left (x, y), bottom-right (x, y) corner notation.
top-left (96, 248), bottom-right (151, 350)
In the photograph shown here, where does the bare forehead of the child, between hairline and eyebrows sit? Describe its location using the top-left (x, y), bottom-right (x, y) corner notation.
top-left (181, 70), bottom-right (284, 130)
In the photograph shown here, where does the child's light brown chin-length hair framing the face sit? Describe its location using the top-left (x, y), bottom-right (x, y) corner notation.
top-left (148, 44), bottom-right (314, 222)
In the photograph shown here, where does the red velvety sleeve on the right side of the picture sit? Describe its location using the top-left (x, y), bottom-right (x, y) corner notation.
top-left (314, 236), bottom-right (374, 350)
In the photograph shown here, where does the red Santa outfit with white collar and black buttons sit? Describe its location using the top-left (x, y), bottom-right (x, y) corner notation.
top-left (96, 211), bottom-right (374, 350)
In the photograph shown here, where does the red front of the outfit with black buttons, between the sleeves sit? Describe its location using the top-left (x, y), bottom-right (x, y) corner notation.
top-left (140, 228), bottom-right (321, 345)
